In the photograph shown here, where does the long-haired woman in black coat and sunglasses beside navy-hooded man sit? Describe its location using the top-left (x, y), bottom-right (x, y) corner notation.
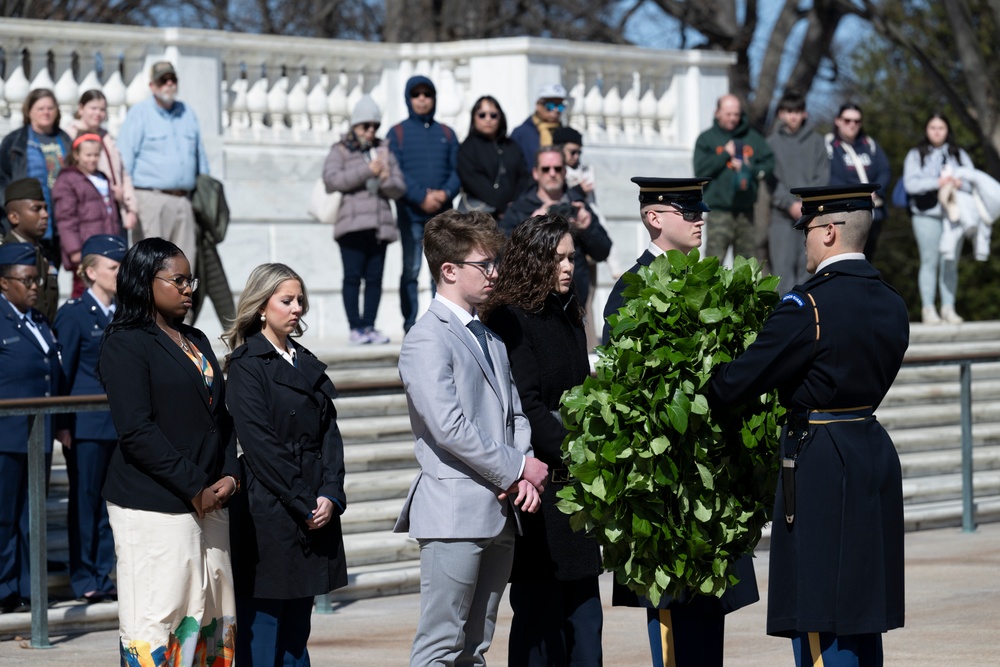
top-left (457, 95), bottom-right (534, 220)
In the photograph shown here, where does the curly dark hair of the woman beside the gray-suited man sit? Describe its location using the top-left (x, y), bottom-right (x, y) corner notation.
top-left (479, 215), bottom-right (583, 324)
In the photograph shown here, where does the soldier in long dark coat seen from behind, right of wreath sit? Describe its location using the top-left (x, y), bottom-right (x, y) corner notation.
top-left (711, 183), bottom-right (909, 667)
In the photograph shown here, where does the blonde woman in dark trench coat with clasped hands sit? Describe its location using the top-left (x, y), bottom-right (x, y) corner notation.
top-left (223, 264), bottom-right (347, 667)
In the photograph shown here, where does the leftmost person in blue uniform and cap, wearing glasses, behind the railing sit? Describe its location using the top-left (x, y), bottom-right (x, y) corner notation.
top-left (0, 243), bottom-right (69, 613)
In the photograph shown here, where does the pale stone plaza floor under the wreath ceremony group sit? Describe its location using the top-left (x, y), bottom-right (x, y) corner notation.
top-left (0, 524), bottom-right (1000, 667)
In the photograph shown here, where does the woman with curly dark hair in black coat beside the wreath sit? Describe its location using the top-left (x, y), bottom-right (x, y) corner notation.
top-left (481, 215), bottom-right (603, 667)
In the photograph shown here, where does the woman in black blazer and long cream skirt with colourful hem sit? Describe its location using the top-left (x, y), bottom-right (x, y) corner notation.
top-left (98, 238), bottom-right (240, 665)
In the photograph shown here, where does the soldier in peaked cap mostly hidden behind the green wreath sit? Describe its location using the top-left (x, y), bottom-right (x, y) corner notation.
top-left (604, 176), bottom-right (760, 667)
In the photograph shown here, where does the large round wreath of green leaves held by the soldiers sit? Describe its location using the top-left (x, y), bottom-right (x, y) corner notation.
top-left (559, 250), bottom-right (784, 604)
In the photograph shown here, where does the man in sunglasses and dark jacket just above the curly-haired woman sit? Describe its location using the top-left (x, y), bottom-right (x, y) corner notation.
top-left (500, 146), bottom-right (611, 303)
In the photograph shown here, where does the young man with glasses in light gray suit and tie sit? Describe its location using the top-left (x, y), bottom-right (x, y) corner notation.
top-left (395, 211), bottom-right (548, 667)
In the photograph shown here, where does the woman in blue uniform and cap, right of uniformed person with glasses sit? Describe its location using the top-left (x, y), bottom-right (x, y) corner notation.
top-left (54, 234), bottom-right (128, 603)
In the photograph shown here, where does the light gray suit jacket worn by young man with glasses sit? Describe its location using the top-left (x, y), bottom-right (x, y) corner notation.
top-left (394, 300), bottom-right (532, 539)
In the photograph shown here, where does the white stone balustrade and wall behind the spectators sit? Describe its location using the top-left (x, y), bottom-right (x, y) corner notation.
top-left (0, 19), bottom-right (732, 342)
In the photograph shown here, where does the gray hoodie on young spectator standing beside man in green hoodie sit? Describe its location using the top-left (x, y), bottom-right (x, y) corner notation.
top-left (767, 119), bottom-right (830, 223)
